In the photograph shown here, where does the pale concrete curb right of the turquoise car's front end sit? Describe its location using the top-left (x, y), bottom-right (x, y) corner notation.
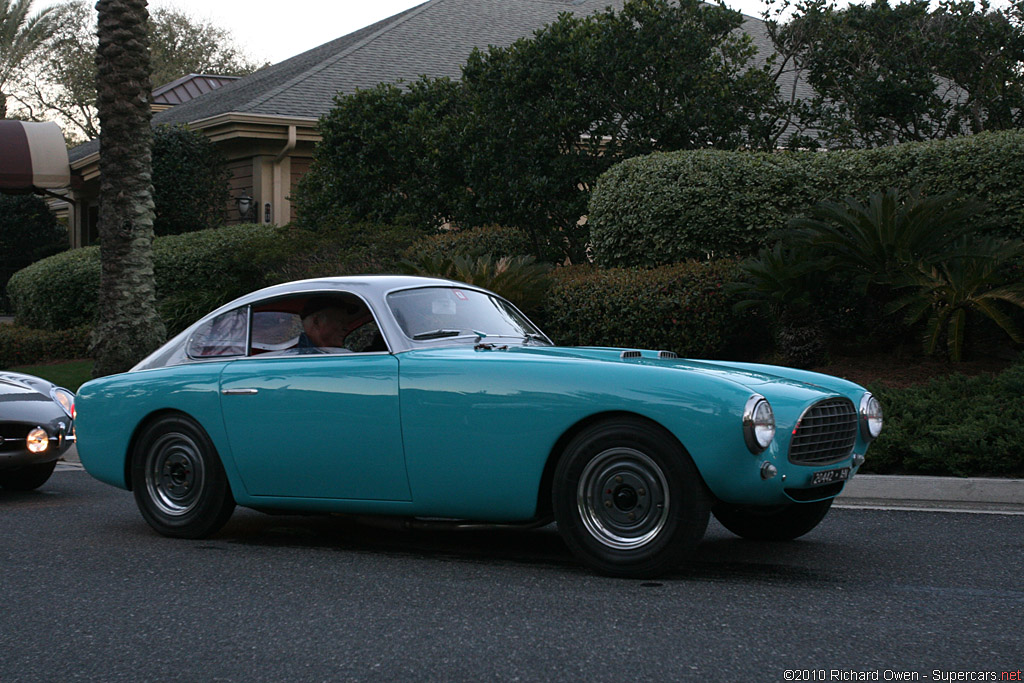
top-left (836, 474), bottom-right (1024, 512)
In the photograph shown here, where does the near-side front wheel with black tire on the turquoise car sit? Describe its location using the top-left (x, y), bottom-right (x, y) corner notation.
top-left (552, 418), bottom-right (710, 579)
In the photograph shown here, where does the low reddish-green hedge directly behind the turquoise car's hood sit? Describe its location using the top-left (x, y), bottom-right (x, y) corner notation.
top-left (544, 261), bottom-right (763, 357)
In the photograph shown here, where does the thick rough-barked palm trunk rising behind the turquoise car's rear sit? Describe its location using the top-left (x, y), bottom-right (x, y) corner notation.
top-left (92, 0), bottom-right (166, 377)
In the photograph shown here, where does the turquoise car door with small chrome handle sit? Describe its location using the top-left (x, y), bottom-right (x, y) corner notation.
top-left (220, 302), bottom-right (411, 501)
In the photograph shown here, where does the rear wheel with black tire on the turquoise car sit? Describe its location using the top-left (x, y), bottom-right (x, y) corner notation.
top-left (131, 416), bottom-right (234, 539)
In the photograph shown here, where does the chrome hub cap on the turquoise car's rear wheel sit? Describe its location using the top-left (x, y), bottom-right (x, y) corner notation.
top-left (145, 433), bottom-right (206, 516)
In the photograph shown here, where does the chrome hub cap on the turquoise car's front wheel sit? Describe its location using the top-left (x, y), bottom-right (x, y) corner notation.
top-left (577, 447), bottom-right (669, 550)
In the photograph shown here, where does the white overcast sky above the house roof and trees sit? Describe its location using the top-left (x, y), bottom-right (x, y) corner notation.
top-left (33, 0), bottom-right (782, 62)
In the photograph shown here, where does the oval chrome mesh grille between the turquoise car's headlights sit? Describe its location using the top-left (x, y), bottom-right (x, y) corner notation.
top-left (790, 398), bottom-right (857, 465)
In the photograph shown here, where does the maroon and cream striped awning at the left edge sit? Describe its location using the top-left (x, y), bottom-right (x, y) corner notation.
top-left (0, 119), bottom-right (71, 193)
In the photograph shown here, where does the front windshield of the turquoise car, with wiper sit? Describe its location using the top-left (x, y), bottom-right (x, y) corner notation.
top-left (387, 287), bottom-right (548, 344)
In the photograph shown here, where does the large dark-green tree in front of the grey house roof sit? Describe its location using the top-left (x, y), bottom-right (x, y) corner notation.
top-left (296, 0), bottom-right (775, 259)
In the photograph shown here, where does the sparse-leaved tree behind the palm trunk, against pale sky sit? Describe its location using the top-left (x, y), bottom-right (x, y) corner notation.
top-left (12, 0), bottom-right (264, 139)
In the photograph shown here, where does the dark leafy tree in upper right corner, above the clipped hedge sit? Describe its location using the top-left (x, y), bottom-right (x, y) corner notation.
top-left (766, 0), bottom-right (1024, 147)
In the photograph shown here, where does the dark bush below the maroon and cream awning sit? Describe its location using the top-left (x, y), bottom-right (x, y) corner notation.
top-left (0, 195), bottom-right (68, 310)
